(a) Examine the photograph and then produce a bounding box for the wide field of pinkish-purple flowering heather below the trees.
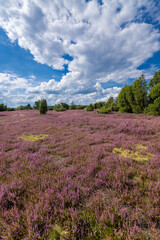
[0,110,160,240]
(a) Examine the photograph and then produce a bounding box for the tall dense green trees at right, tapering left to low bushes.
[87,70,160,115]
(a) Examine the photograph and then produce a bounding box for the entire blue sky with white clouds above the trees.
[0,0,160,107]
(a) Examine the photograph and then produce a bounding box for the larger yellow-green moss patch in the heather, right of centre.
[113,148,151,162]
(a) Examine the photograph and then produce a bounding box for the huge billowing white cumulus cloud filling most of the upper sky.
[0,0,160,105]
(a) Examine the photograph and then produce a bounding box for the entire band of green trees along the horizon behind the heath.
[0,70,160,115]
